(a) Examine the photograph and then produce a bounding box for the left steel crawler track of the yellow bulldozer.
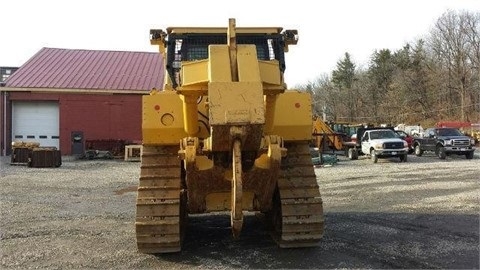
[135,145,186,253]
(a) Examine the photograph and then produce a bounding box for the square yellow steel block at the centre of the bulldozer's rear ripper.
[208,82,265,125]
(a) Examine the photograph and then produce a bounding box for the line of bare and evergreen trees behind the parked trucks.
[300,10,480,126]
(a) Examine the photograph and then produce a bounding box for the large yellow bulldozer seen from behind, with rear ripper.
[135,19,324,253]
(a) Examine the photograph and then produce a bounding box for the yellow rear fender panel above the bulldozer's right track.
[271,91,312,141]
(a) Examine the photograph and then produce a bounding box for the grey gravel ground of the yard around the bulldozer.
[0,153,480,269]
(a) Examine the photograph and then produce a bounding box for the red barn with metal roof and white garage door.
[0,48,164,155]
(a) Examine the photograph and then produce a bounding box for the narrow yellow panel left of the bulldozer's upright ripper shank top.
[208,45,232,82]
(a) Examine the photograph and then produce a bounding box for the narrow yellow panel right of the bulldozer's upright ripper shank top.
[237,45,260,82]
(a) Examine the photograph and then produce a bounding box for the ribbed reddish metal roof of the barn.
[5,48,164,90]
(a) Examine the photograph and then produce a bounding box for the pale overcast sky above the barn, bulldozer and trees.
[0,0,480,87]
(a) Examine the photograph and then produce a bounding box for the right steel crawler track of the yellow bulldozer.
[267,143,324,248]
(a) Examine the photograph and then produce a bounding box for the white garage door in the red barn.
[12,101,60,149]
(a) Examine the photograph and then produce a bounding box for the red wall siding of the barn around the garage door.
[10,92,142,155]
